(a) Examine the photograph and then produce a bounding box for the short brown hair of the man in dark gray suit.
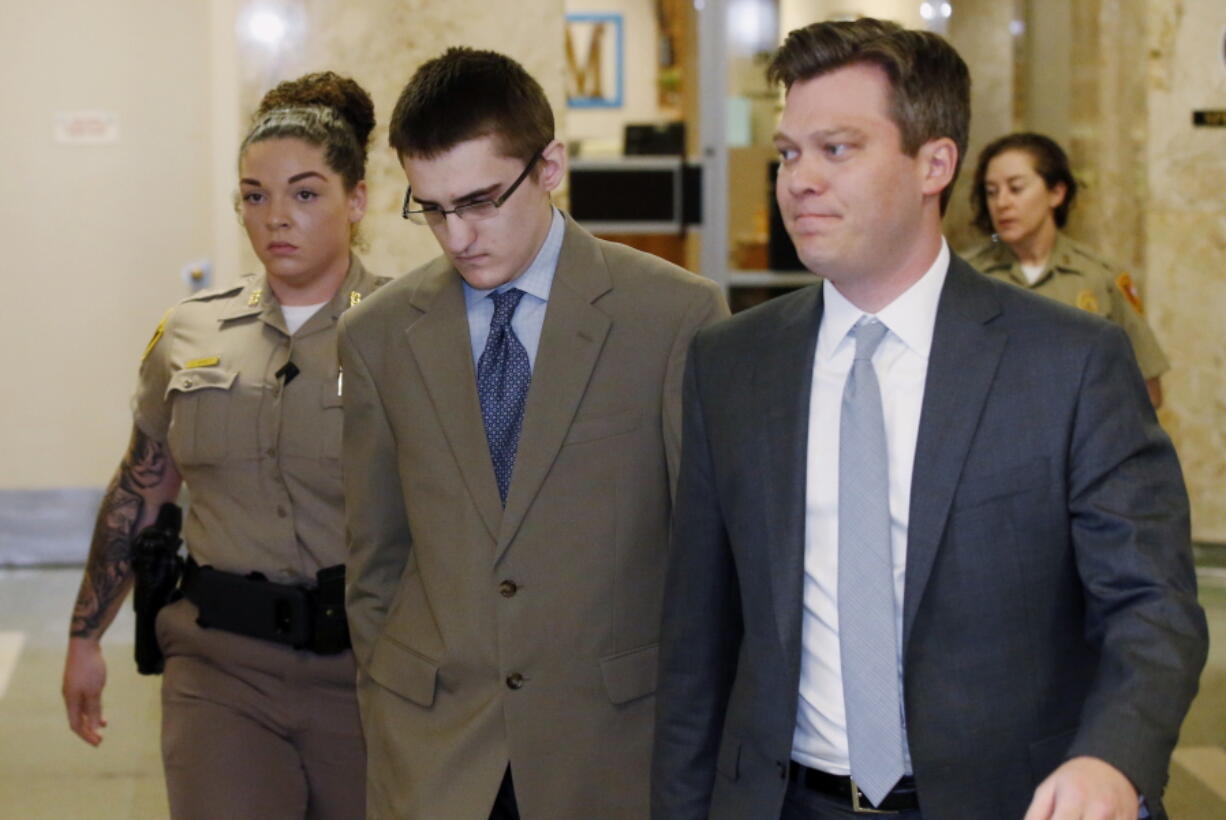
[766,17,971,213]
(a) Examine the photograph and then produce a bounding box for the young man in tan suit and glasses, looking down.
[341,49,727,820]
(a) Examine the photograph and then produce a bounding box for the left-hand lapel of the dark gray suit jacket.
[747,286,823,663]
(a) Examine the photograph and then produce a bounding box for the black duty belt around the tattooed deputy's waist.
[183,558,349,655]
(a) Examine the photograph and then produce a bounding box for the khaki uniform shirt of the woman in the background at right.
[966,234,1171,380]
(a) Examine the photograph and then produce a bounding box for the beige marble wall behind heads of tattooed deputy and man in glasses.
[230,0,565,281]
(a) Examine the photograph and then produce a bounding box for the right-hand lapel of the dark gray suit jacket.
[902,256,1008,646]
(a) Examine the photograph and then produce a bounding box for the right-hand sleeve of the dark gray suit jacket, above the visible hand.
[1068,318,1208,802]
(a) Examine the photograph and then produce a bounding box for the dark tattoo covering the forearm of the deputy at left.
[69,428,170,637]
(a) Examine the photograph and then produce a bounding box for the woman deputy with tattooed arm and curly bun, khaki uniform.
[57,72,381,818]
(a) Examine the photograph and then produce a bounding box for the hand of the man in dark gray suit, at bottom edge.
[1025,757,1139,820]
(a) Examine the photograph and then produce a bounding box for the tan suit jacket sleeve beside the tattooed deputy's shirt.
[340,314,412,668]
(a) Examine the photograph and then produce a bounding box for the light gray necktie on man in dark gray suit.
[839,319,905,805]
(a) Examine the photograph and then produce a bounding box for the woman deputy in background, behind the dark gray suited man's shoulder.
[967,132,1170,407]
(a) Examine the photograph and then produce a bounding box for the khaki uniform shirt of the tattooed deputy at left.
[132,256,386,583]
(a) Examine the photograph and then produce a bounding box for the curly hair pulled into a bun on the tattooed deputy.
[238,71,375,190]
